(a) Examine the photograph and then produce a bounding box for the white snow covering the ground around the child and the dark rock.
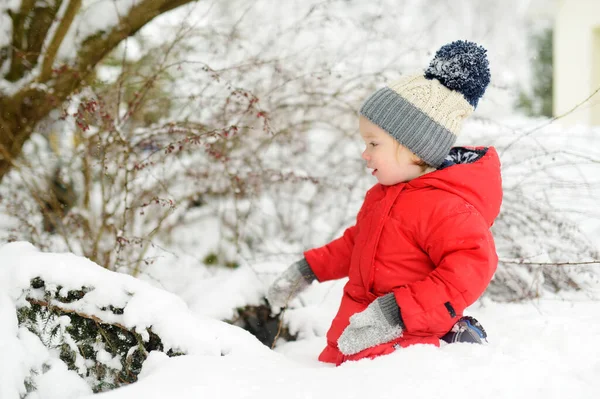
[0,243,600,399]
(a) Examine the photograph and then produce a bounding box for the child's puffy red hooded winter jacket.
[304,147,502,365]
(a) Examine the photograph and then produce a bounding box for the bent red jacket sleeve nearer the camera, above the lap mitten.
[394,211,498,336]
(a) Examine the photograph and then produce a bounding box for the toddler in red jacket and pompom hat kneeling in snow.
[267,40,502,365]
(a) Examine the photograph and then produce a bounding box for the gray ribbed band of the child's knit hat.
[360,87,456,168]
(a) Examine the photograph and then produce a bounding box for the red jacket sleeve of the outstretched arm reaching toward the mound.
[304,226,356,282]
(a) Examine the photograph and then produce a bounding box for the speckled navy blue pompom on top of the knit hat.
[425,40,490,107]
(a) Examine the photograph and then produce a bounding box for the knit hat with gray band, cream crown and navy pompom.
[360,40,490,168]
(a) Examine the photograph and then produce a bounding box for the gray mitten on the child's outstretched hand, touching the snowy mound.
[267,258,317,308]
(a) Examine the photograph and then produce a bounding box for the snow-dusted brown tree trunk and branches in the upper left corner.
[0,0,197,180]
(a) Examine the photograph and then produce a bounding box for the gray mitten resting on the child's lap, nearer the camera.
[338,294,403,355]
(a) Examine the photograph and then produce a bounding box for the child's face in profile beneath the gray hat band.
[359,116,426,186]
